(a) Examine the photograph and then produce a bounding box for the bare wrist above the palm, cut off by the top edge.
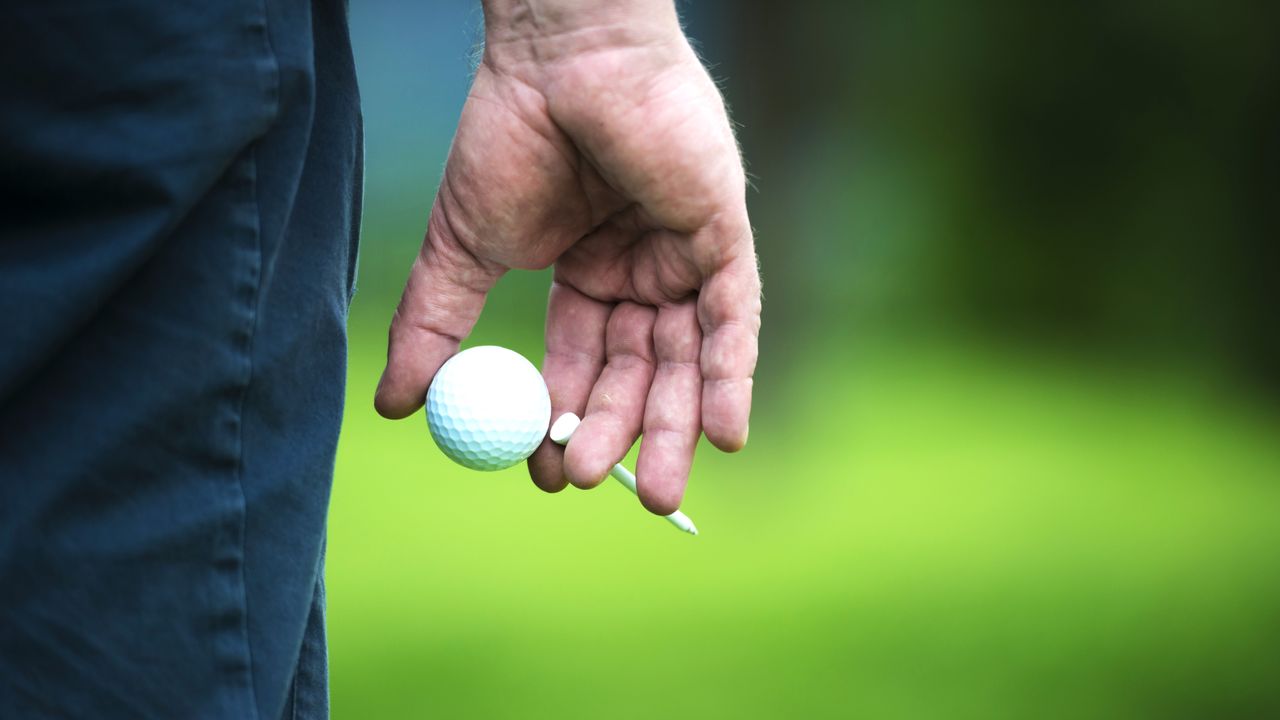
[483,0,687,69]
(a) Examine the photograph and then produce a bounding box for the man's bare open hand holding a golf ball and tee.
[375,0,760,514]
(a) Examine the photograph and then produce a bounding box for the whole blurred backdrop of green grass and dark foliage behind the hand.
[328,0,1280,719]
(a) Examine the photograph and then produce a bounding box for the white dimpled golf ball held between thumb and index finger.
[426,345,552,470]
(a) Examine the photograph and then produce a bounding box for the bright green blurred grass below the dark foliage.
[328,304,1280,719]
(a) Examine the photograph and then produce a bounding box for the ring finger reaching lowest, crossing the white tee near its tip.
[636,300,703,515]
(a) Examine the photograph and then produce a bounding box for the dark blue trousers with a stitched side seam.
[0,0,362,719]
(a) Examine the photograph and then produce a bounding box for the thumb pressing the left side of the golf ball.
[374,200,504,419]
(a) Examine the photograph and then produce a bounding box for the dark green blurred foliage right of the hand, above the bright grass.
[727,0,1280,380]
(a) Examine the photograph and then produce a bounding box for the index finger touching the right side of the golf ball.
[529,282,613,492]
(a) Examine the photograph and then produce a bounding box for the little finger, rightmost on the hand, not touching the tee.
[698,229,760,452]
